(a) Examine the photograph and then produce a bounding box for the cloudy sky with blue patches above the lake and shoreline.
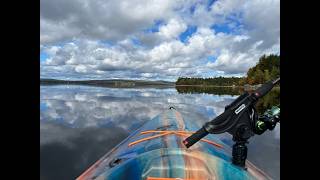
[40,0,280,81]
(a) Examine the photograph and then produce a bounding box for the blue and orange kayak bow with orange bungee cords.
[77,107,271,180]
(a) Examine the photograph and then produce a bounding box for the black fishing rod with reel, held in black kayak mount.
[183,77,280,167]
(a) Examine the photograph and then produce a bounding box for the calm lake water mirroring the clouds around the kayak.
[40,85,280,180]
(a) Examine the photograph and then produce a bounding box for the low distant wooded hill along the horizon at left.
[40,79,175,88]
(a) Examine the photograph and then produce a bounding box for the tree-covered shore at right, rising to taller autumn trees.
[176,54,280,86]
